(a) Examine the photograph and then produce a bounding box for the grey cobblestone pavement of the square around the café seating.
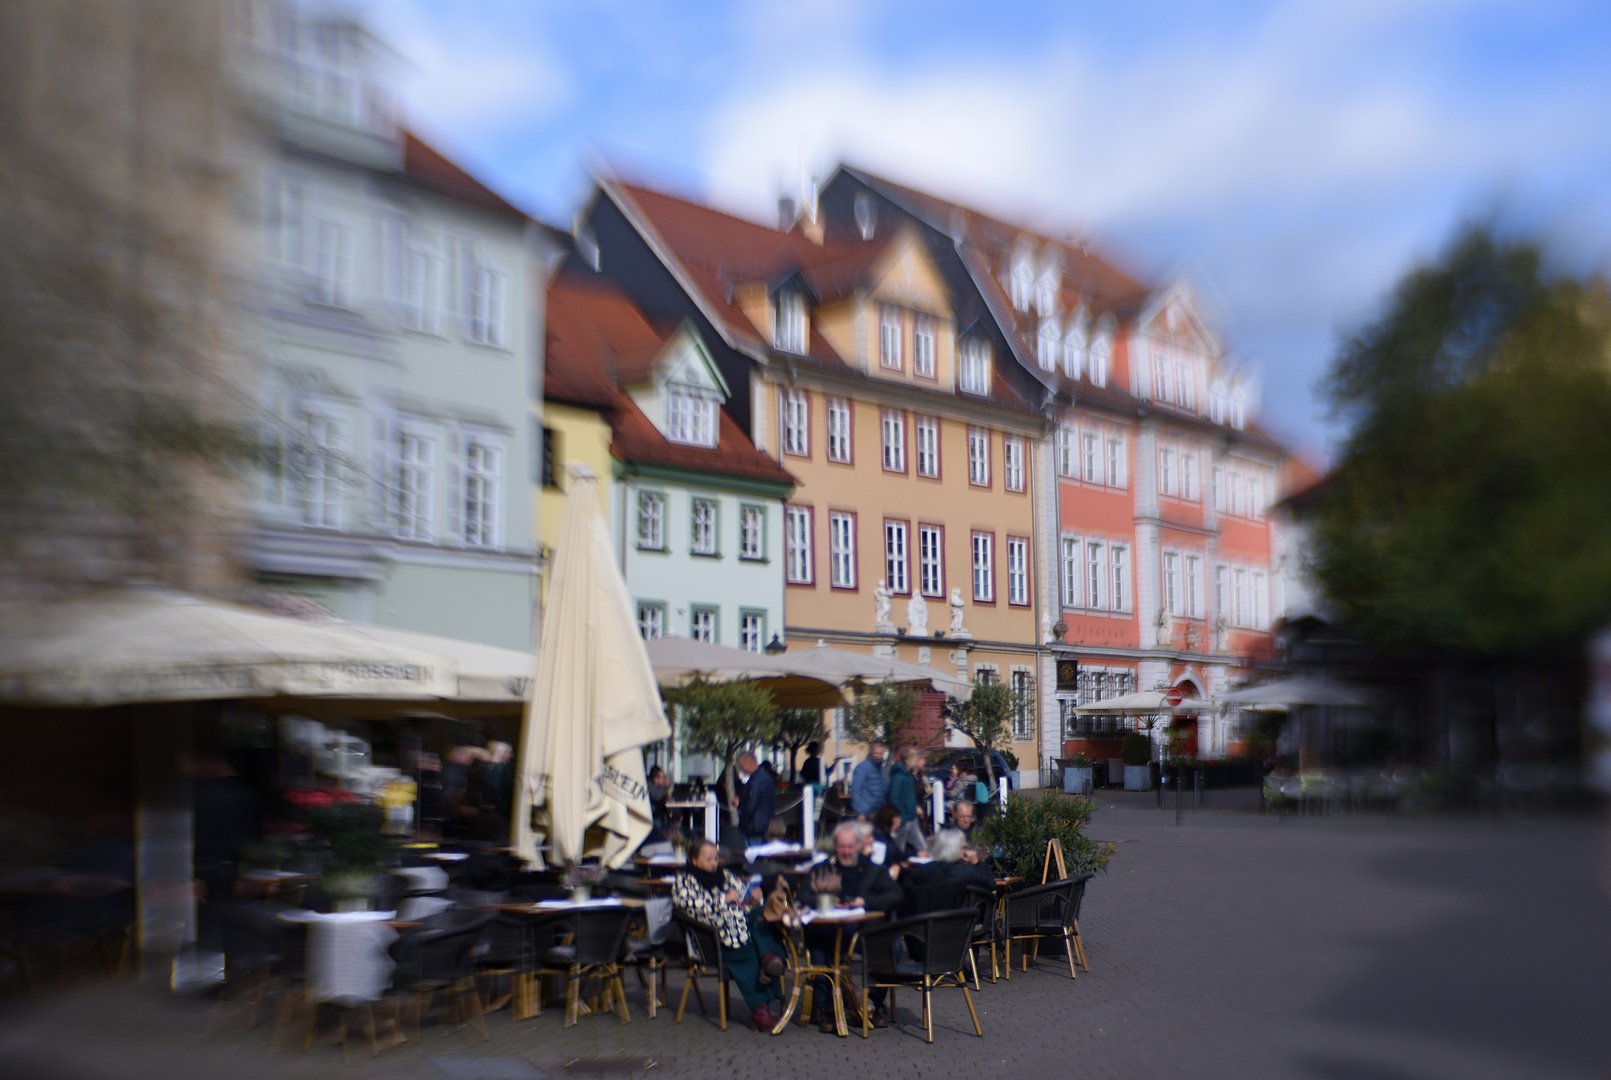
[0,791,1611,1080]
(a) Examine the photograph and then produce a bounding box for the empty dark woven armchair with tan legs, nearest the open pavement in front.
[862,908,984,1043]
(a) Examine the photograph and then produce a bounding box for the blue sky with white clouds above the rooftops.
[356,0,1611,464]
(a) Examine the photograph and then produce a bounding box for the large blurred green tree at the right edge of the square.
[1307,227,1611,653]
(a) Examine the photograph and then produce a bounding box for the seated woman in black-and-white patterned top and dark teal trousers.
[672,840,783,1032]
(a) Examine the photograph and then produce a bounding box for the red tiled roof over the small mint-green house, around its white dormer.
[543,256,796,487]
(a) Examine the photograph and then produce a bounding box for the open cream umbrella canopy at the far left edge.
[0,585,458,708]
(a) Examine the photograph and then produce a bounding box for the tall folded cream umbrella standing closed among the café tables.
[514,469,670,866]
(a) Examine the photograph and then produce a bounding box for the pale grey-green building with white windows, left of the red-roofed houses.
[246,11,551,648]
